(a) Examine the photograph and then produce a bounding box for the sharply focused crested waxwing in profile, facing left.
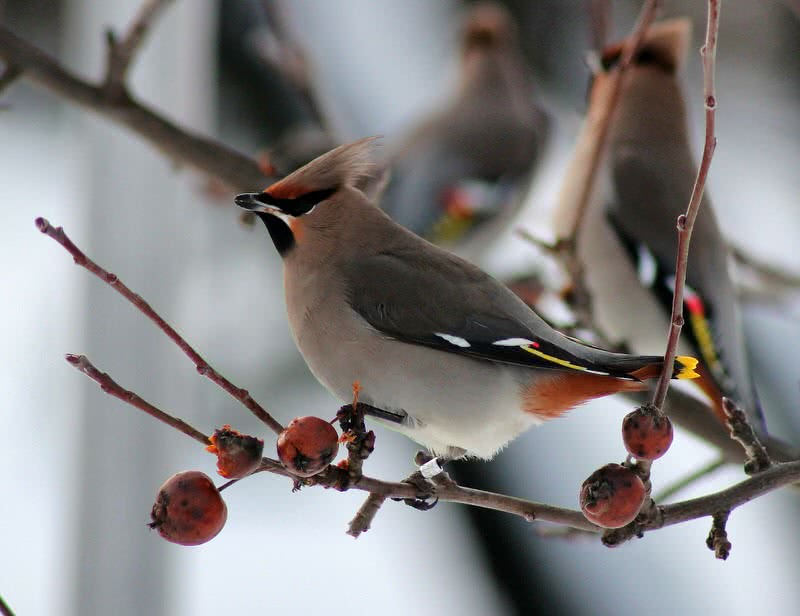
[236,138,696,458]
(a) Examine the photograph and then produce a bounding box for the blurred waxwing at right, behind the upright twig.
[554,19,765,434]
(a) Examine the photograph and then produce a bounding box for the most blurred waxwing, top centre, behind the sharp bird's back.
[383,3,548,247]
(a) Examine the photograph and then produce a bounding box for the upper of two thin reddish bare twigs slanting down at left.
[36,218,283,434]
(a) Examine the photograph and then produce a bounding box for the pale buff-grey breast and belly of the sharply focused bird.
[293,298,540,458]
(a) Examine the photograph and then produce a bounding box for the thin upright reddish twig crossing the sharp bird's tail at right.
[653,0,720,409]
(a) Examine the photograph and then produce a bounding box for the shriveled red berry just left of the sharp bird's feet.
[278,416,339,477]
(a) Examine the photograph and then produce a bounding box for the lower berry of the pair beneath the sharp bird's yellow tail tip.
[580,464,645,528]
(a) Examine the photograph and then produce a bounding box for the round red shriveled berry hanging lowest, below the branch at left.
[150,471,228,545]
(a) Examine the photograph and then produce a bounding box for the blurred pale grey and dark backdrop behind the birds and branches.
[0,0,800,616]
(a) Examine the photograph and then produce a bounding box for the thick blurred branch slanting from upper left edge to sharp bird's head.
[0,26,271,190]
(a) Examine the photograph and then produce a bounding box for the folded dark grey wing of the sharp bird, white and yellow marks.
[346,247,661,378]
